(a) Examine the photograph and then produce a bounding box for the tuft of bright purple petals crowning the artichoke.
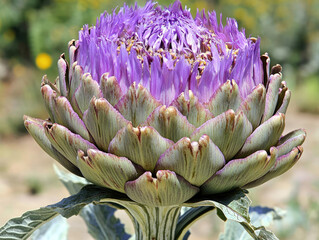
[77,1,263,104]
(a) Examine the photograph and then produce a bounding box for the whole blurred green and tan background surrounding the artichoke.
[0,0,319,240]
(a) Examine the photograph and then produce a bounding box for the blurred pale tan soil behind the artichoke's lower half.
[0,100,319,240]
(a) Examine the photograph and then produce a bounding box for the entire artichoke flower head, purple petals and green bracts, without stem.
[25,1,305,206]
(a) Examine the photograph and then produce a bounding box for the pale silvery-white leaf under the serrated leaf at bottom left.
[30,216,68,240]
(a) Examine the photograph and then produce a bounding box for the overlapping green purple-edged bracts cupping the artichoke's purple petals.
[25,0,305,206]
